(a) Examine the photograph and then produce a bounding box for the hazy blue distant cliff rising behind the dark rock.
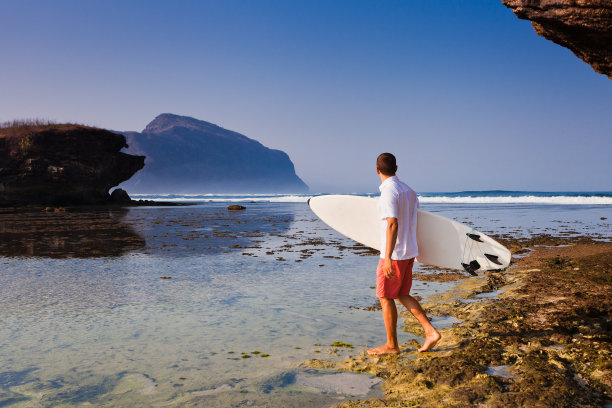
[122,113,308,194]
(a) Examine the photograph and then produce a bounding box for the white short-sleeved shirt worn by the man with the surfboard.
[378,176,419,261]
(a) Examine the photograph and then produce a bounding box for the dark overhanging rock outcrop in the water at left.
[0,125,144,206]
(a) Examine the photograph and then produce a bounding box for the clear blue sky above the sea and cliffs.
[0,0,612,192]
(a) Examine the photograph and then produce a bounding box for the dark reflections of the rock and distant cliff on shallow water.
[0,205,294,258]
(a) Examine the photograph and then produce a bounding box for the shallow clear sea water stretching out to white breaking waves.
[0,191,612,407]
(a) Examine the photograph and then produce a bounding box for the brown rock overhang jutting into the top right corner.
[502,0,612,78]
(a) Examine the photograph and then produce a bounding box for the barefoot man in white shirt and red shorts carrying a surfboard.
[368,153,441,355]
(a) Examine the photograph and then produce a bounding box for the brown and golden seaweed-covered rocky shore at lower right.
[304,236,612,407]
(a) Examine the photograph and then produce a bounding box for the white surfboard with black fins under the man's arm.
[308,195,511,275]
